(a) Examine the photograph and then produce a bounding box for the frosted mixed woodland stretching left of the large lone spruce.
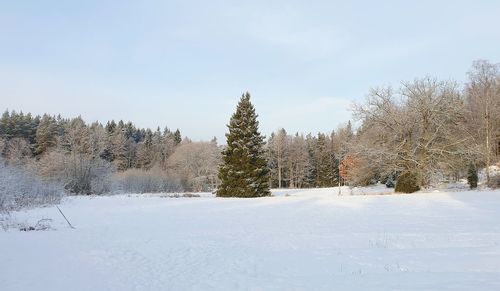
[0,111,220,194]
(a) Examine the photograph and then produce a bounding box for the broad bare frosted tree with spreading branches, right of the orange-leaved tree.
[352,78,473,186]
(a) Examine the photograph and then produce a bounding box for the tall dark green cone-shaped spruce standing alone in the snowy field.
[217,92,271,197]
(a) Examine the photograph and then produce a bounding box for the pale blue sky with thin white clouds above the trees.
[0,0,500,140]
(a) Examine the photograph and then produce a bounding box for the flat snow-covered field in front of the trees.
[0,188,500,291]
